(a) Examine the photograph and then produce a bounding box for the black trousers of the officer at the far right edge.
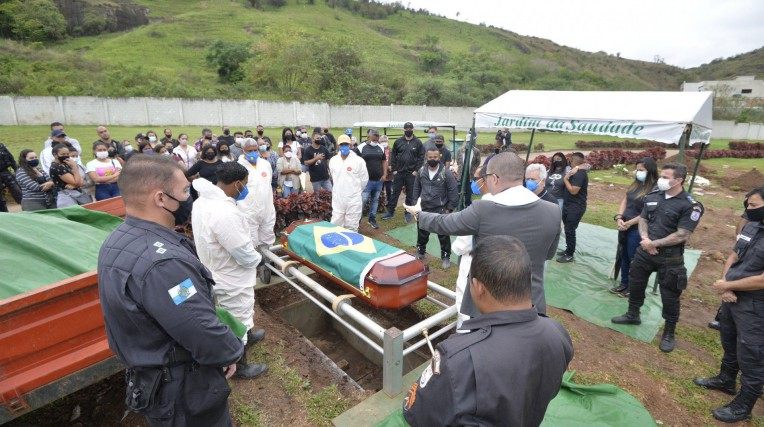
[719,298,764,401]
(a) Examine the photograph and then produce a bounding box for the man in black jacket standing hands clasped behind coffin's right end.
[414,146,459,268]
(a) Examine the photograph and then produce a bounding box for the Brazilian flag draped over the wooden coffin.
[288,221,403,290]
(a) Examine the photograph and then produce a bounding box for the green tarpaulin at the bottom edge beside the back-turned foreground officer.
[377,372,656,427]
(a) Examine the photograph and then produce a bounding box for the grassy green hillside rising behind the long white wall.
[0,0,762,106]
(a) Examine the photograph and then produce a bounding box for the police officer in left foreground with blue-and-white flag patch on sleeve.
[98,154,244,426]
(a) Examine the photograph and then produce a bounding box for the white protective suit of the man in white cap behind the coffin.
[329,151,369,231]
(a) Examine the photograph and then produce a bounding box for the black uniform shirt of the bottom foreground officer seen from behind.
[403,308,573,426]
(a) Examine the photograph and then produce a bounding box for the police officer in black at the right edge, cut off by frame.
[695,187,764,423]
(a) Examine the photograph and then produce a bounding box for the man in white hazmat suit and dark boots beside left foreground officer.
[191,162,268,378]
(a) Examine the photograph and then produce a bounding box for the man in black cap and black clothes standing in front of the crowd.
[382,122,424,222]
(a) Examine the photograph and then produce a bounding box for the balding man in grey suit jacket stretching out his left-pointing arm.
[405,151,561,317]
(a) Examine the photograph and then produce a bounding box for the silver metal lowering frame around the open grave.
[261,245,457,397]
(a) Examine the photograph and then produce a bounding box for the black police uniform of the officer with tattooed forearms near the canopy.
[624,190,703,333]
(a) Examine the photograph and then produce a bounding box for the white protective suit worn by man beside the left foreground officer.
[191,178,262,344]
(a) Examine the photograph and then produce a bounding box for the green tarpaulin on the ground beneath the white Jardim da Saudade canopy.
[544,223,700,342]
